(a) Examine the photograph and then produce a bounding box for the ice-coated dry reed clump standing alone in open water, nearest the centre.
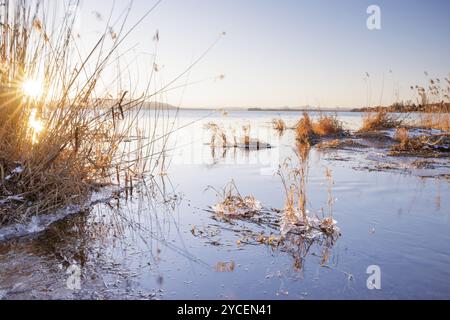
[200,136,340,272]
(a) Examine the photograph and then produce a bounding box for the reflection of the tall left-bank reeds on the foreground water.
[0,177,201,299]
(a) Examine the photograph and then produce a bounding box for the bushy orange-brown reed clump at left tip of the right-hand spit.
[295,112,345,144]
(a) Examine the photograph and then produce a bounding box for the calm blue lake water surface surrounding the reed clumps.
[0,111,450,299]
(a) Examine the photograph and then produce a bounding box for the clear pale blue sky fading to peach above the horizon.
[74,0,450,108]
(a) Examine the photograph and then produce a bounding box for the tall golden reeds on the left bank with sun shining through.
[0,0,165,226]
